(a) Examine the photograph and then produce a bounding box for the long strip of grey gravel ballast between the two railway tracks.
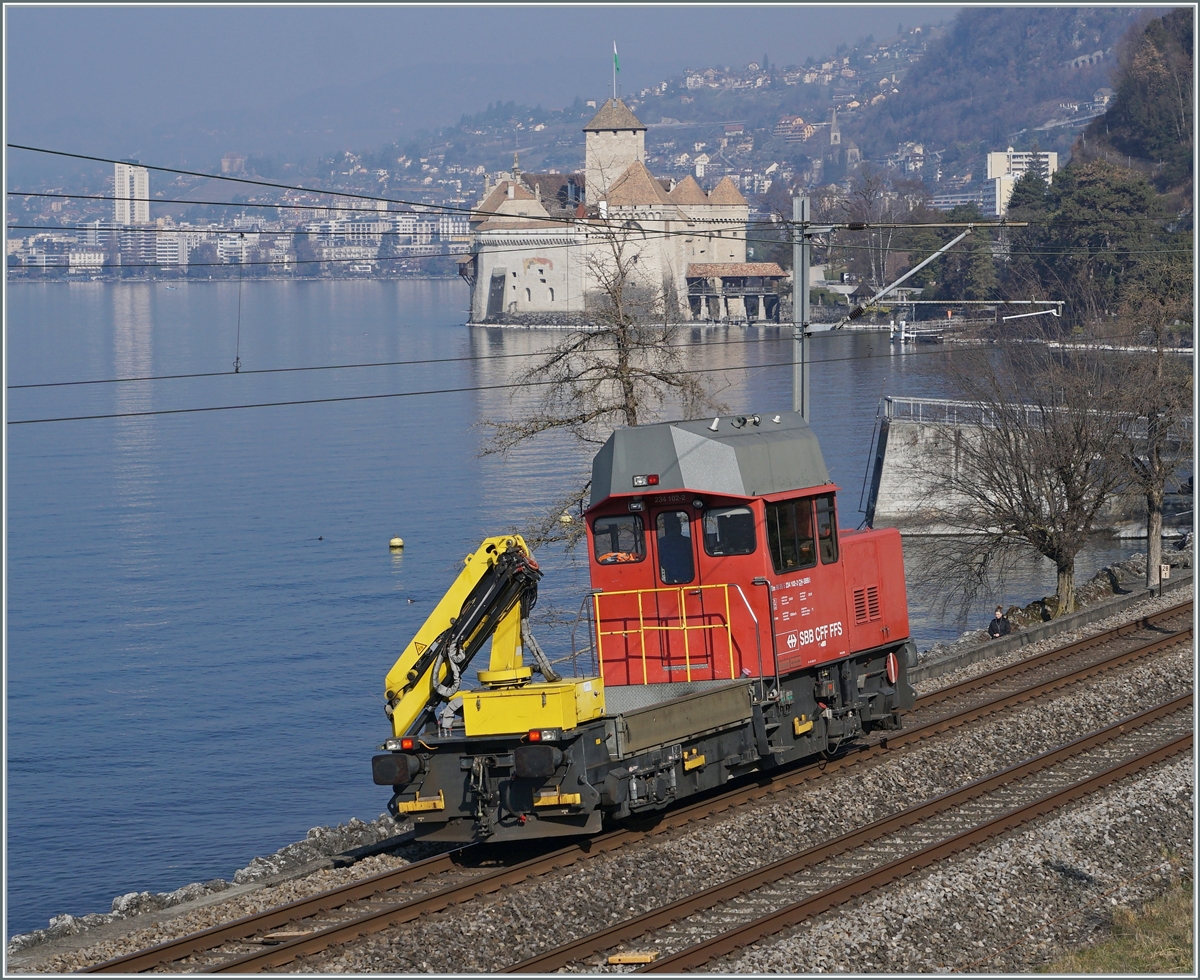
[278,633,1192,973]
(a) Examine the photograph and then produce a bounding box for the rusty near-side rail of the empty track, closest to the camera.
[637,732,1193,973]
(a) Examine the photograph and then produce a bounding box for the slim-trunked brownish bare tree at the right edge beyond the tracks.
[1122,260,1193,589]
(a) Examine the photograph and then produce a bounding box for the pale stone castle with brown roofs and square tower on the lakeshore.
[460,98,787,326]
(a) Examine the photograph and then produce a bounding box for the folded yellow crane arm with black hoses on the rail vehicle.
[386,535,541,736]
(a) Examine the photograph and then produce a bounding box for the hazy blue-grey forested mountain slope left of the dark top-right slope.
[844,6,1144,167]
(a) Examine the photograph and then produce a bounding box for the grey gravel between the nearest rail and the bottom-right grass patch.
[709,753,1194,973]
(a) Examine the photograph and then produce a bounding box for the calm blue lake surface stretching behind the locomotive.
[6,281,1136,936]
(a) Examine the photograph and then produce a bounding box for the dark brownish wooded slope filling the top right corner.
[1078,7,1195,192]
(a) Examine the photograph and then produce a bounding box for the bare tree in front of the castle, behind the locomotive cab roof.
[482,223,725,541]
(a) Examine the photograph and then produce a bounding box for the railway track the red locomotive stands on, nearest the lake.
[80,602,1192,973]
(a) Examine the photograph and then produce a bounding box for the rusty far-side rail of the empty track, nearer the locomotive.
[499,692,1193,973]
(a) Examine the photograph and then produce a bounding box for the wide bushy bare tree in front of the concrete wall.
[920,344,1128,615]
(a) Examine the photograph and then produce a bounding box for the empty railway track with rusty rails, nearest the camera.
[503,693,1193,973]
